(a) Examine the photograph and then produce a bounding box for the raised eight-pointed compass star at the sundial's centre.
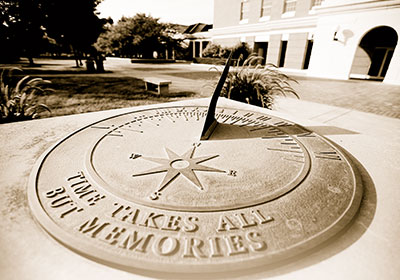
[132,146,225,200]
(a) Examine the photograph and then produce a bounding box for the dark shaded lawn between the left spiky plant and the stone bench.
[8,74,195,118]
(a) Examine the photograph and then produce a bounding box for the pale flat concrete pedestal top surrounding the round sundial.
[0,99,400,279]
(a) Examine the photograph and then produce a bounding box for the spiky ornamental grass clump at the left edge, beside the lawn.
[0,68,51,123]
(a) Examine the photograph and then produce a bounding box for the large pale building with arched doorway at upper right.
[207,0,400,84]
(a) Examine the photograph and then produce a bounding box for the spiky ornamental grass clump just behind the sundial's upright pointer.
[217,55,299,109]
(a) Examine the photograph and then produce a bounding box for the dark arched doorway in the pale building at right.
[350,26,398,80]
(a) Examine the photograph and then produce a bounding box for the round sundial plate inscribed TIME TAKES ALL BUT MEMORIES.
[29,56,362,273]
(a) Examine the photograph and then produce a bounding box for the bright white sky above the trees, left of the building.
[97,0,214,25]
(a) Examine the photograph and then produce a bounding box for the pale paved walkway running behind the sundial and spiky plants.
[5,58,400,118]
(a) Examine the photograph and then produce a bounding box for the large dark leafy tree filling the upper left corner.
[0,0,107,66]
